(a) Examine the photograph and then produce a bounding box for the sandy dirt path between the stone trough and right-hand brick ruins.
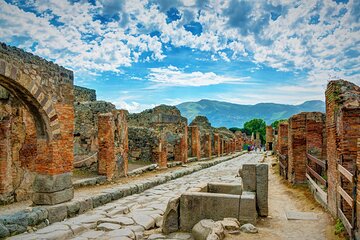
[225,157,345,240]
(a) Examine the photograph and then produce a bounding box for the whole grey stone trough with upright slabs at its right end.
[162,164,268,234]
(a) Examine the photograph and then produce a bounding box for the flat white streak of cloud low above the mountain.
[147,66,249,87]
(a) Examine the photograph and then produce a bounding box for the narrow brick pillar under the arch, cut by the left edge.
[0,119,12,202]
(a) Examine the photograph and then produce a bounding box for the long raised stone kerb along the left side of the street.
[0,152,244,238]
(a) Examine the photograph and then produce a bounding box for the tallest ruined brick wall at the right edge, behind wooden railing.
[325,80,360,221]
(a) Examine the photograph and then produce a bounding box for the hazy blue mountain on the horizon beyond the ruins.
[176,99,325,128]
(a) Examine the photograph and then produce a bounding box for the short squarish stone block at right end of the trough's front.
[239,192,257,224]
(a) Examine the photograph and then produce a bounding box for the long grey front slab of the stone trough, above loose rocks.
[180,192,240,231]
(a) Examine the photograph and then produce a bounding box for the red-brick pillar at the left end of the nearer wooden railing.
[288,113,306,184]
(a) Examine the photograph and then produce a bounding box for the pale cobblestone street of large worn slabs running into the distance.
[11,154,263,240]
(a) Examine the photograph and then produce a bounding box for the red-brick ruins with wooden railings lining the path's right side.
[269,80,360,239]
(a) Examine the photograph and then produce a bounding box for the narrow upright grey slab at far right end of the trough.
[256,163,269,216]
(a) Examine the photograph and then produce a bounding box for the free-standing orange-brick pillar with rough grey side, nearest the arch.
[98,110,128,180]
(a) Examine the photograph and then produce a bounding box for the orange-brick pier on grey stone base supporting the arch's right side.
[32,103,74,205]
